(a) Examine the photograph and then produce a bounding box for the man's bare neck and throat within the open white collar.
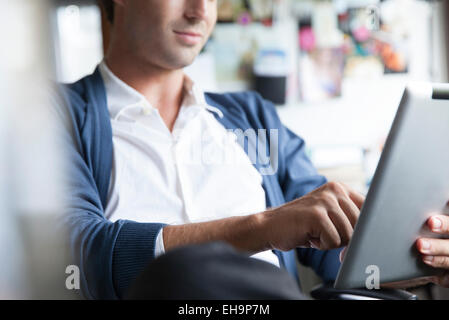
[105,53,184,131]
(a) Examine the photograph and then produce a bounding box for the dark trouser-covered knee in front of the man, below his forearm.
[125,242,304,300]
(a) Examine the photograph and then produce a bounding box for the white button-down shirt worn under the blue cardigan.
[100,62,279,266]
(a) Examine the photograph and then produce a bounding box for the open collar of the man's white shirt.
[99,60,223,119]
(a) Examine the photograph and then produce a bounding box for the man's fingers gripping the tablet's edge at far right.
[416,202,449,288]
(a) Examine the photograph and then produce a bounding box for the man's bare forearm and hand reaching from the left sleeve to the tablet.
[163,182,365,253]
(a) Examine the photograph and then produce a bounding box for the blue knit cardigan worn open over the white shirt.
[53,69,340,299]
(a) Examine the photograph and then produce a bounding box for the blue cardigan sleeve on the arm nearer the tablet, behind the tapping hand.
[254,94,341,282]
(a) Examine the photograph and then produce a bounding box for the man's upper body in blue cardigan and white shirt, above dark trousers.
[55,0,448,299]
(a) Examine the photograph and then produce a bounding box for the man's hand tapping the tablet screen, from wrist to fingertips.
[263,182,365,251]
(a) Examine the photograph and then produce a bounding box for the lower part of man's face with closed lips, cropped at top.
[116,0,217,70]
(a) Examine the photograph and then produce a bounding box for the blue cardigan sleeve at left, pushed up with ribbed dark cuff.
[52,88,164,299]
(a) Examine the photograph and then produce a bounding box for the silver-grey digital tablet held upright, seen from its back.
[334,83,449,289]
